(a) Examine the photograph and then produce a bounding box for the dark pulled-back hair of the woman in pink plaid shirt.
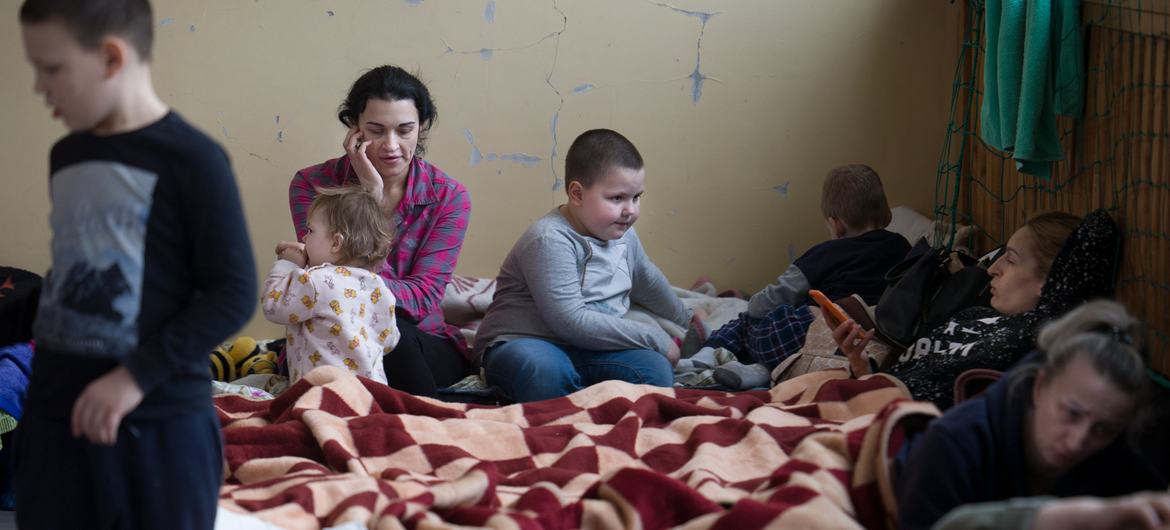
[337,64,439,157]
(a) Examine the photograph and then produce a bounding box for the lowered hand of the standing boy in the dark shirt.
[71,366,143,446]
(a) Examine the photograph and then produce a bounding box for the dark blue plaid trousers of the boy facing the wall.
[703,305,813,370]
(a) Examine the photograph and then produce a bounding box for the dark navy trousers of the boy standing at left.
[13,407,223,530]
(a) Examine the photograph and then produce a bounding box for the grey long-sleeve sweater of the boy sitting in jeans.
[474,208,688,364]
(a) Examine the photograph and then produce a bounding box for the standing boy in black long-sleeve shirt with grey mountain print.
[15,0,256,529]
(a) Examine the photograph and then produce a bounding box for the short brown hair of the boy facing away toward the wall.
[820,164,892,230]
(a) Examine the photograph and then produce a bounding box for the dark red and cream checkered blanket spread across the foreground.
[215,367,937,529]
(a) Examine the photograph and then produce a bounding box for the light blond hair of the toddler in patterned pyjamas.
[309,186,394,273]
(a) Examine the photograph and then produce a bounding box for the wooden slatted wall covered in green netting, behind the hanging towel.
[934,0,1170,381]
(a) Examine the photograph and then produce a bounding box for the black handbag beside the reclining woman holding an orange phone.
[874,238,998,349]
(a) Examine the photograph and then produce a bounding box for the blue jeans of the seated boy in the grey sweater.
[483,338,674,402]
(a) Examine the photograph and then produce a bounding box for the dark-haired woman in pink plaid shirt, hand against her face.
[289,66,472,395]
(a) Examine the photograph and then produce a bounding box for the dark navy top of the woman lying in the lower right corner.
[897,358,1166,529]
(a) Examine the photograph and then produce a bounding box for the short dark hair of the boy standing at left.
[20,0,154,61]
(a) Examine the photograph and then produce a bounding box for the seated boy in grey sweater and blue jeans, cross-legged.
[474,129,689,402]
